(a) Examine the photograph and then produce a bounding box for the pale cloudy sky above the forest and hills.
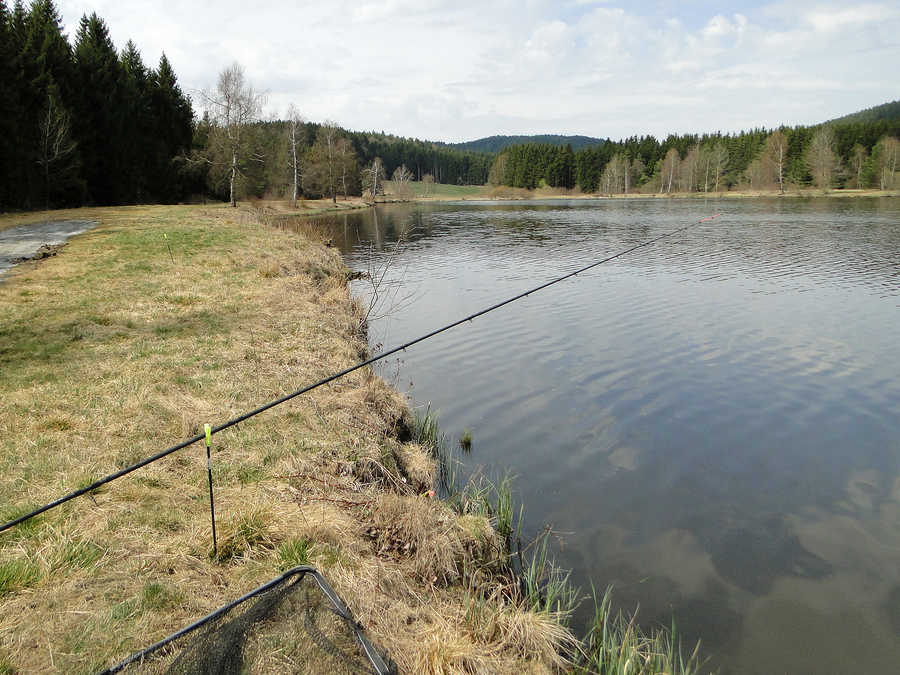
[57,0,900,142]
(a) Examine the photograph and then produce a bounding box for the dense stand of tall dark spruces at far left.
[0,0,196,209]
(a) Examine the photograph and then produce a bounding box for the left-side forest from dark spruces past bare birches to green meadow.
[0,0,493,209]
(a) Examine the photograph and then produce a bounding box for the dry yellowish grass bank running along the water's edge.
[0,206,569,673]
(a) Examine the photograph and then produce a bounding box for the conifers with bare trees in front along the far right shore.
[490,118,900,194]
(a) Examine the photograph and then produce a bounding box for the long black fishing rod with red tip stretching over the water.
[0,213,722,532]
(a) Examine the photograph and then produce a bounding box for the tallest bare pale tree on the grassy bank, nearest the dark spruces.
[203,62,266,206]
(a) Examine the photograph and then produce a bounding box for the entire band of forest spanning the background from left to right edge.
[0,0,900,209]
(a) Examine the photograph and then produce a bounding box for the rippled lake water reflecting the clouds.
[326,199,900,673]
